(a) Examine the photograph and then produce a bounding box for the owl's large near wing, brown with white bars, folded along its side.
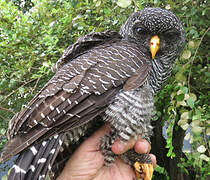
[1,41,149,161]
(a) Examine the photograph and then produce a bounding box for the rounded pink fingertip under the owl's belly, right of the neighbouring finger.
[134,139,151,154]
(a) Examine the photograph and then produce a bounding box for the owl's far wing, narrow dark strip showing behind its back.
[52,30,121,72]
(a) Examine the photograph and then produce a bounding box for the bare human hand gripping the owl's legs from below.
[57,125,156,180]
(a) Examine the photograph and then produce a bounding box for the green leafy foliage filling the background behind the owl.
[0,0,210,179]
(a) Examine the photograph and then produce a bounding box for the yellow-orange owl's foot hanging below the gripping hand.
[133,162,154,180]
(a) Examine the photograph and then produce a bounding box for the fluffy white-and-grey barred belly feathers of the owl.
[104,85,154,140]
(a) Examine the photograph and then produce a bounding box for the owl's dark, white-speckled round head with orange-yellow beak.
[120,8,185,60]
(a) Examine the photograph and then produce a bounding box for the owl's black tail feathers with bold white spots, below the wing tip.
[8,134,64,180]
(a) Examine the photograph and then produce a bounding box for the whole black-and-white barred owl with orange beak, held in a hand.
[1,8,185,180]
